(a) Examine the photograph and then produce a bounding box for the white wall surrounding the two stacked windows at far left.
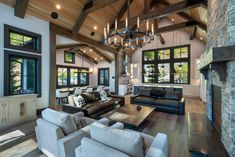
[0,3,49,109]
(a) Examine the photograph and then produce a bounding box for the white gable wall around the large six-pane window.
[132,20,205,97]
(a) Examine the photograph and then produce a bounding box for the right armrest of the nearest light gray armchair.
[145,133,168,157]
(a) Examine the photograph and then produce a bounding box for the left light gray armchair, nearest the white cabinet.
[35,109,109,157]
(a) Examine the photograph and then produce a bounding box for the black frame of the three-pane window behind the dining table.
[56,65,90,89]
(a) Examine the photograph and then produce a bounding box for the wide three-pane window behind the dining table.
[57,65,89,88]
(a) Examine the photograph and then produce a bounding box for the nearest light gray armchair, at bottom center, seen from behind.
[76,122,168,157]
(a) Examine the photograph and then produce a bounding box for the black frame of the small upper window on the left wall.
[4,24,42,54]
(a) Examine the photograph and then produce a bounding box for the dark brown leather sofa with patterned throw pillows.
[62,91,125,118]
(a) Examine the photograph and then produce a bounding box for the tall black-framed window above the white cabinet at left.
[4,51,41,96]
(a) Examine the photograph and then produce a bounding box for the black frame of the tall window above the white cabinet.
[4,50,42,97]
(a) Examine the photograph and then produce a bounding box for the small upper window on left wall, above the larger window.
[4,25,41,53]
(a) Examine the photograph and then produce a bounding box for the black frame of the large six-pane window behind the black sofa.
[142,44,191,85]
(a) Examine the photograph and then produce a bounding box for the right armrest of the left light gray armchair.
[58,130,89,157]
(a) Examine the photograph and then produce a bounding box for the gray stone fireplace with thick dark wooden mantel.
[200,0,235,157]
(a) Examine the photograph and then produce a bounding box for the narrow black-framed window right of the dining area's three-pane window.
[98,68,109,86]
